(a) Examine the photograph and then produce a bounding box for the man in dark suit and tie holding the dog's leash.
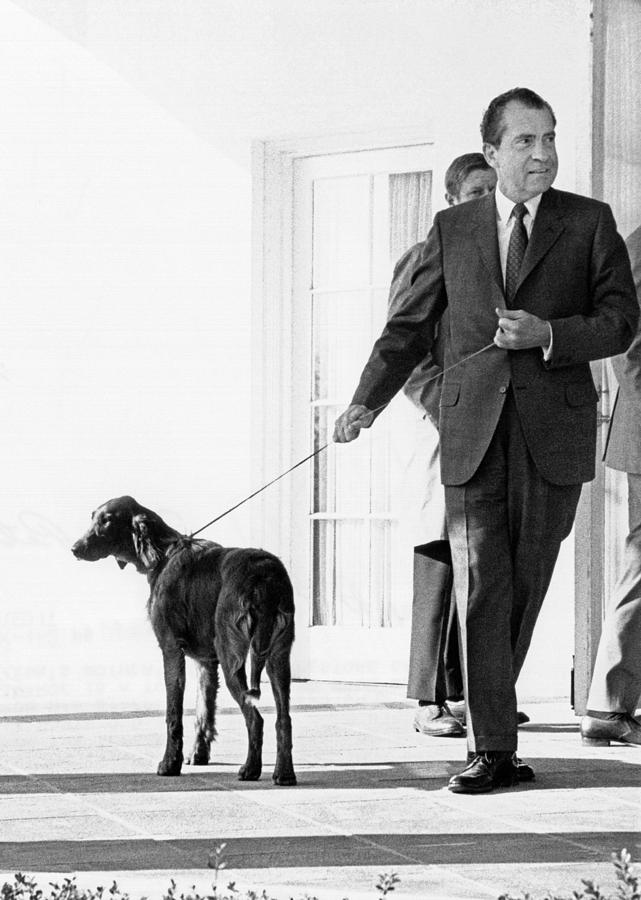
[334,88,638,793]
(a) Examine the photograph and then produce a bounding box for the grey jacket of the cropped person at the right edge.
[605,227,641,475]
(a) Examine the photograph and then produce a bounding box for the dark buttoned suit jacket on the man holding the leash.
[352,188,639,484]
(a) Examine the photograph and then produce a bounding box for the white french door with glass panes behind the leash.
[290,145,432,682]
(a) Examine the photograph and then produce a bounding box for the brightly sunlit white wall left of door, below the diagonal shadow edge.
[0,4,250,712]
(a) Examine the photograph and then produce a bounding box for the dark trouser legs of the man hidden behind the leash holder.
[407,540,463,706]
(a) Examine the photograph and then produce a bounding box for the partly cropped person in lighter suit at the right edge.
[581,228,641,747]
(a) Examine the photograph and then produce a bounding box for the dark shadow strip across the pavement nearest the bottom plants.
[0,831,641,872]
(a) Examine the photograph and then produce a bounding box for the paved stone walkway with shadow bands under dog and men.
[0,682,641,900]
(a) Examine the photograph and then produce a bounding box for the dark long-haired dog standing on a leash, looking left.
[72,497,296,785]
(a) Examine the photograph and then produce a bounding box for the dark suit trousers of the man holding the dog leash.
[445,388,581,752]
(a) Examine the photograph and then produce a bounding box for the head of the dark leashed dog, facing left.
[71,497,172,572]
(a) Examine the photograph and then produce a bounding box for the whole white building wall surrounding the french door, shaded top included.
[0,0,589,714]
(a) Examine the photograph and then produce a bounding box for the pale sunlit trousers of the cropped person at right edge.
[588,473,641,715]
